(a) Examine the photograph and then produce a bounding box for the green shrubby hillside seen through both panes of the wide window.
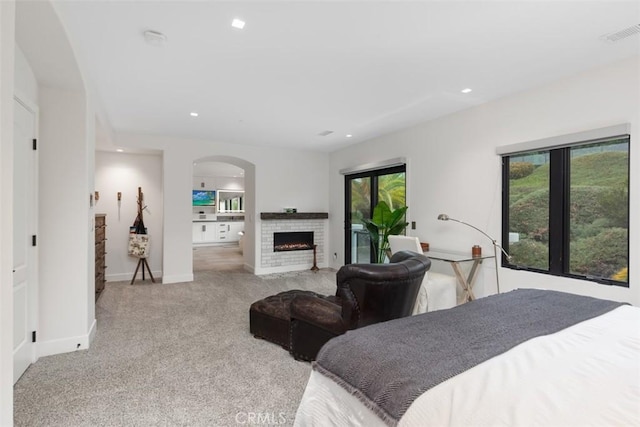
[509,151,629,277]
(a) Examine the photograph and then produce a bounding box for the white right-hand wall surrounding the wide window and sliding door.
[330,57,640,305]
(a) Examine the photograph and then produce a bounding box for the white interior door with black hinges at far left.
[13,99,37,384]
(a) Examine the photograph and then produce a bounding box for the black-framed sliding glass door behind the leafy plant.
[344,165,406,264]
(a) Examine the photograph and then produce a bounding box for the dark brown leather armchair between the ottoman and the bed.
[289,251,431,361]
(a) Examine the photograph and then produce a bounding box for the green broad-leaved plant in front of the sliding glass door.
[362,201,409,264]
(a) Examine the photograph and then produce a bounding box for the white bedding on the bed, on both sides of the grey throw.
[295,306,640,427]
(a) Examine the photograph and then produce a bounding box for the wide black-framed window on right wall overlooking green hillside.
[502,135,630,286]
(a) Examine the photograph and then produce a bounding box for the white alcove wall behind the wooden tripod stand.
[95,151,163,282]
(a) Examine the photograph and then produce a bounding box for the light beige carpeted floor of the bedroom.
[14,270,335,426]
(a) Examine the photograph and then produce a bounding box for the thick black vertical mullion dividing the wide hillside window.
[549,149,569,274]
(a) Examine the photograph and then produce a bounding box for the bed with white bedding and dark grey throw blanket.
[295,289,640,427]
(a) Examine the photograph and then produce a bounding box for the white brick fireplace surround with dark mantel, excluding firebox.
[260,212,329,272]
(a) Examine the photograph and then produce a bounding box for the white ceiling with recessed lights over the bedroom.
[50,0,640,151]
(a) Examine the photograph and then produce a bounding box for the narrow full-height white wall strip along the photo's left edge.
[0,0,15,426]
